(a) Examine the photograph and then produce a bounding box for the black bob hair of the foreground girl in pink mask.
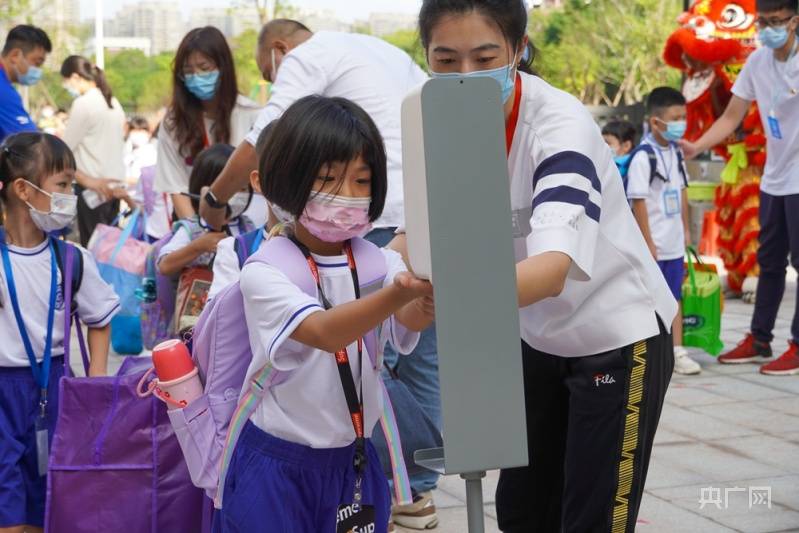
[258,96,388,222]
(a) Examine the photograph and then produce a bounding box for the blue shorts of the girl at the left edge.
[0,357,64,527]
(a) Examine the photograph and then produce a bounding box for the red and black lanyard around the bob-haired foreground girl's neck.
[292,239,366,474]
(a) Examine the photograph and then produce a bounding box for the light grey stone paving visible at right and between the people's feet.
[398,273,799,533]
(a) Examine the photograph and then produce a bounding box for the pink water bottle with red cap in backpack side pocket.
[139,340,203,409]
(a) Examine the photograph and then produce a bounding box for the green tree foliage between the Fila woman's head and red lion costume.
[530,0,682,105]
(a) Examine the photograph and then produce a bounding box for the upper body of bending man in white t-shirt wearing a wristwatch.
[200,19,427,232]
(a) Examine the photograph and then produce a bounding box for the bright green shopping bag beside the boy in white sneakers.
[682,247,724,355]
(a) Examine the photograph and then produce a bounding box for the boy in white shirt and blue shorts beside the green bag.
[627,87,701,374]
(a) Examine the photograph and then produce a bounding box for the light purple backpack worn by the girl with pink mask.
[168,237,410,509]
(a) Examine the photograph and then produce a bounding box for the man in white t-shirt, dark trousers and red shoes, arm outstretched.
[682,0,799,375]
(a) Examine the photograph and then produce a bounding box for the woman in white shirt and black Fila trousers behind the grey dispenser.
[419,0,677,533]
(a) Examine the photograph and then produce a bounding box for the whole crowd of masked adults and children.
[0,0,799,533]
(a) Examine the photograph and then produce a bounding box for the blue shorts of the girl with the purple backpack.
[213,422,391,533]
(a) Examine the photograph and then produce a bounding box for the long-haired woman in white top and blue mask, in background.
[155,26,266,225]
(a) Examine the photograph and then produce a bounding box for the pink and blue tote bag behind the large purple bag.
[88,209,151,355]
